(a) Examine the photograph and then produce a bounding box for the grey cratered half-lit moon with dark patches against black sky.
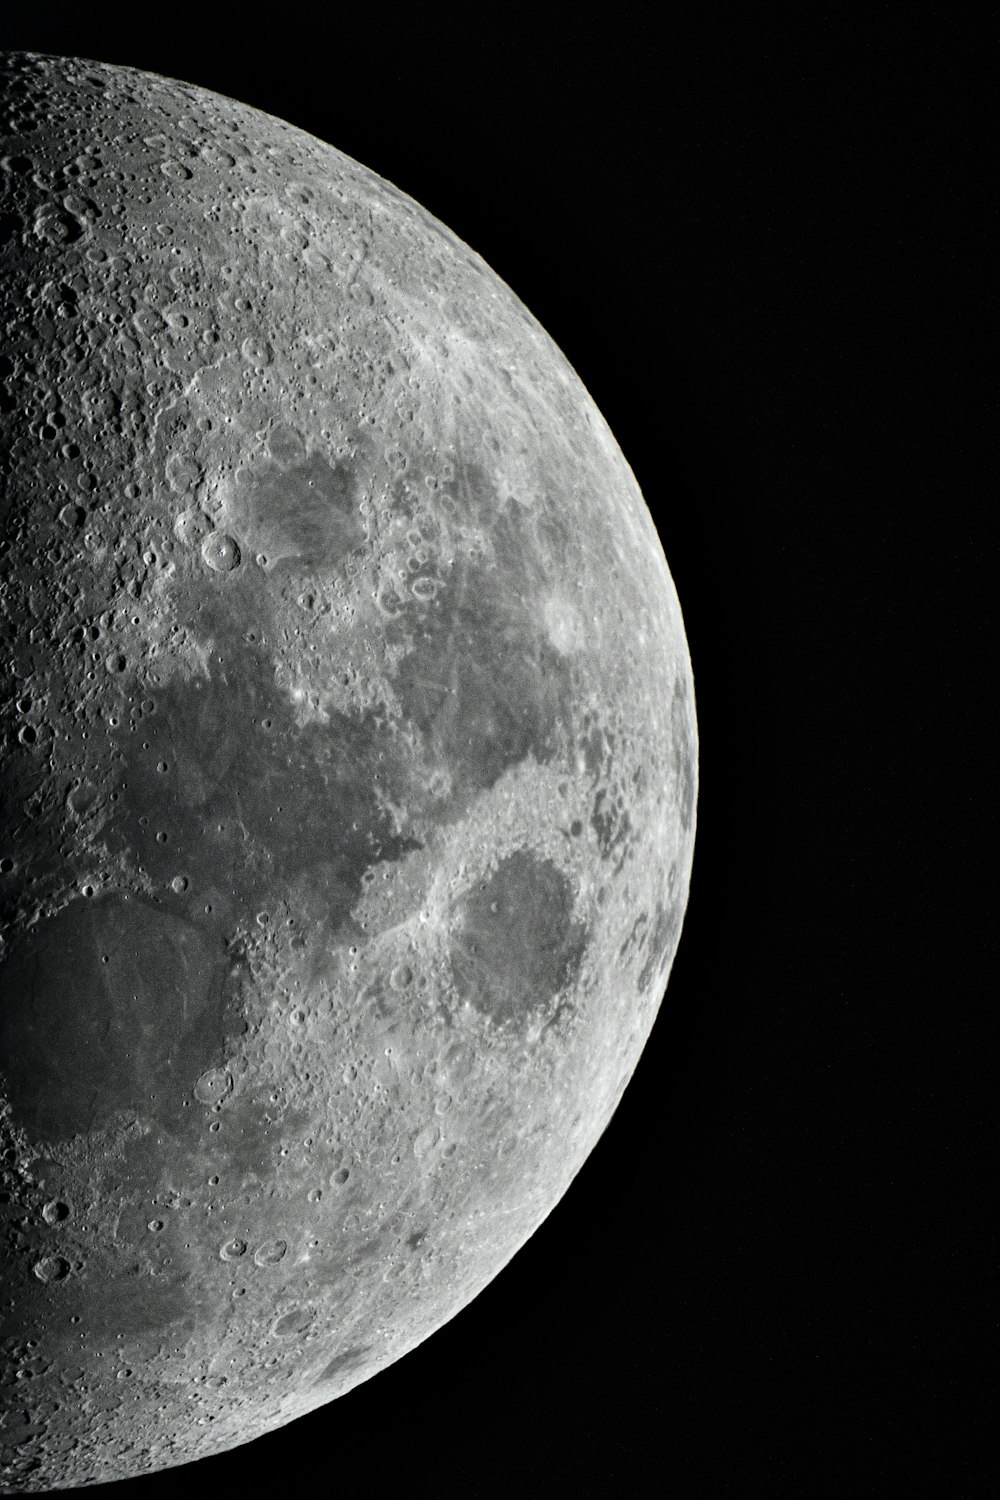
[0,54,697,1491]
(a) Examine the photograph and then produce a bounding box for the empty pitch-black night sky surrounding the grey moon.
[0,3,996,1500]
